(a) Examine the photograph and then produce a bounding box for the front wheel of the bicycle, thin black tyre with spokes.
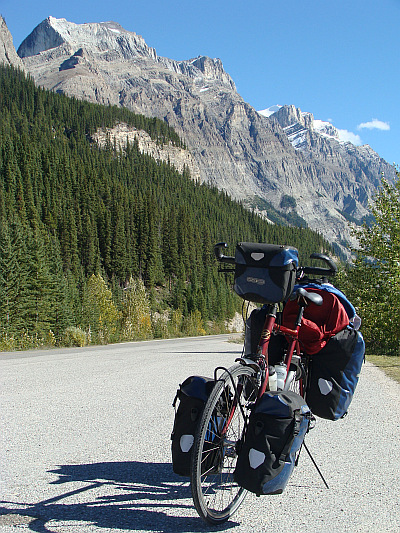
[191,364,258,524]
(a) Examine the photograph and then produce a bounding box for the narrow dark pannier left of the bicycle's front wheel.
[171,376,215,476]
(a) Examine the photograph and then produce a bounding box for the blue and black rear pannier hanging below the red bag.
[306,327,365,420]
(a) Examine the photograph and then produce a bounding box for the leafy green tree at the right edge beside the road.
[342,175,400,355]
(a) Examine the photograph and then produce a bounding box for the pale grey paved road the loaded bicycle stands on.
[0,336,400,533]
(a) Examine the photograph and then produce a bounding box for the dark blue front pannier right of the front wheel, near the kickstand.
[234,391,313,496]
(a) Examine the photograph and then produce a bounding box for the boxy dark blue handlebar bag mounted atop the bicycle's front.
[233,242,298,303]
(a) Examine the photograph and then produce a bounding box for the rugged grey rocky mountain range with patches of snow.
[0,17,395,255]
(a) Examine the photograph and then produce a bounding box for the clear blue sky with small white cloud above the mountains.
[0,0,400,165]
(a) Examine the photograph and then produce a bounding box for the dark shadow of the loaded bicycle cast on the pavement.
[0,461,237,533]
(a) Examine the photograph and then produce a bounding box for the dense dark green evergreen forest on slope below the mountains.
[0,66,330,350]
